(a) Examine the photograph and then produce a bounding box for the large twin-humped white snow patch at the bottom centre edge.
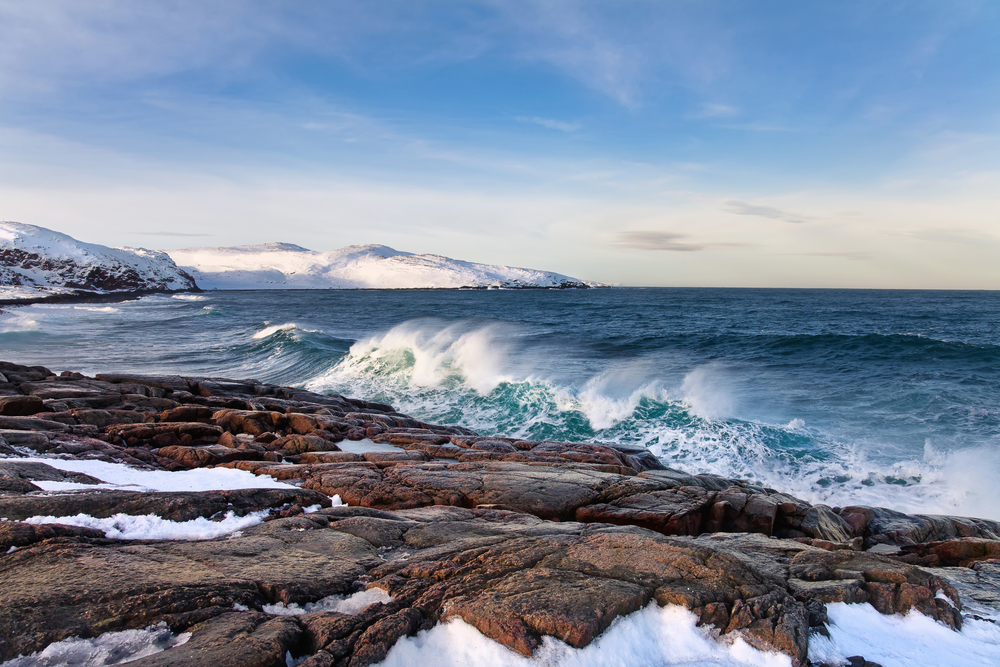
[379,603,792,667]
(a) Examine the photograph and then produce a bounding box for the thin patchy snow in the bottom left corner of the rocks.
[0,623,191,667]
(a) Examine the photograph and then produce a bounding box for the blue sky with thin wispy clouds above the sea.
[0,0,1000,289]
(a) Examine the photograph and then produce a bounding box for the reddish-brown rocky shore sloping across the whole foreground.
[0,362,1000,667]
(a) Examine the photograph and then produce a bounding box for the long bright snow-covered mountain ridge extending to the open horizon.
[167,243,601,289]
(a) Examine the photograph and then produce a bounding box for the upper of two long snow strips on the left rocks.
[4,458,296,491]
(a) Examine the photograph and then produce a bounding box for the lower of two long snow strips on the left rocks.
[23,510,269,540]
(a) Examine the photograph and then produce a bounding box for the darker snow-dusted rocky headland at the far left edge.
[0,222,197,299]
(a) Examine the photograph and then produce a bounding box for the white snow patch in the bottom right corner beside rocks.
[809,602,1000,667]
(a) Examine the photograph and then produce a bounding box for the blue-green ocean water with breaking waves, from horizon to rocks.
[0,288,1000,519]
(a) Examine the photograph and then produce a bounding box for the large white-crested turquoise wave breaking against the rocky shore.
[304,319,1000,518]
